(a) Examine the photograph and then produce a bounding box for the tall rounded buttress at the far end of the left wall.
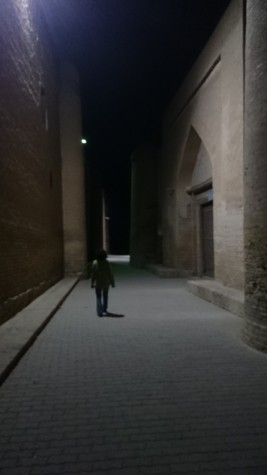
[60,63,87,275]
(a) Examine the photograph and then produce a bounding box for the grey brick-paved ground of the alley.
[0,265,267,475]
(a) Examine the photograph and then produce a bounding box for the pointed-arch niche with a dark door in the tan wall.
[177,126,214,277]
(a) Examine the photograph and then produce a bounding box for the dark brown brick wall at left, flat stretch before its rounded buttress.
[0,0,63,323]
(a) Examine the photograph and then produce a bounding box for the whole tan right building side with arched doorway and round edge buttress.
[131,0,267,351]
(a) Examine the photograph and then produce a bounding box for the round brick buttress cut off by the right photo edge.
[243,0,267,352]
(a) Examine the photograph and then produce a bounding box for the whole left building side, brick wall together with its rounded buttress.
[0,0,86,323]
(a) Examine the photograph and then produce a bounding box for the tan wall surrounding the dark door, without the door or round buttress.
[160,0,244,289]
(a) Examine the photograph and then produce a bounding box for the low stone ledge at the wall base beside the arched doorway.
[187,279,244,317]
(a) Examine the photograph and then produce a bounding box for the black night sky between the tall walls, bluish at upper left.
[45,0,230,253]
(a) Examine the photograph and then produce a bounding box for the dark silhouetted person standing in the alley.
[91,249,115,317]
